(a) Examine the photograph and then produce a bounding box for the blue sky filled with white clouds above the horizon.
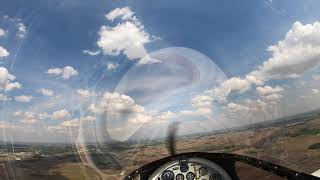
[0,0,320,142]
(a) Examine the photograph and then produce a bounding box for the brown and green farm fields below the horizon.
[0,114,320,180]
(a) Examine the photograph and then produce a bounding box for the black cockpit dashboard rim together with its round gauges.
[125,152,319,180]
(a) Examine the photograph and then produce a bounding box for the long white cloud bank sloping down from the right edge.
[208,22,320,99]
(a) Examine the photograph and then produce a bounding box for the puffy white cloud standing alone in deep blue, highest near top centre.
[97,7,159,64]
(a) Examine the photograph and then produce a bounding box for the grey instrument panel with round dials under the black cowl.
[149,157,231,180]
